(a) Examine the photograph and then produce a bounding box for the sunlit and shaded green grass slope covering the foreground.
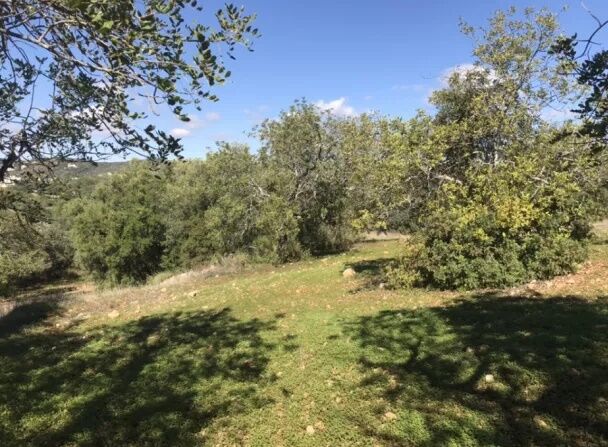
[0,241,608,447]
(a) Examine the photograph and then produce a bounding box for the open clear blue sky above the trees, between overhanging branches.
[156,0,608,157]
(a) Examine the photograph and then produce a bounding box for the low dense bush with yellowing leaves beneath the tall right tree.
[393,160,590,290]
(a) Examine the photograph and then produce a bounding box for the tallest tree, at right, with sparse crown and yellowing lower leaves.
[384,10,597,289]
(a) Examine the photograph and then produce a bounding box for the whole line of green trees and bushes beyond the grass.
[0,11,608,289]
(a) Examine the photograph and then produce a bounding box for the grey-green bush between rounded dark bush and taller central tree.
[164,144,300,266]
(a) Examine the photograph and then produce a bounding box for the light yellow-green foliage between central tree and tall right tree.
[339,111,441,232]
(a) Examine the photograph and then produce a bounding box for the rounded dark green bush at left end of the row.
[68,162,165,284]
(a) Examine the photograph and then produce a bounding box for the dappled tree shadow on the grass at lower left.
[0,308,275,447]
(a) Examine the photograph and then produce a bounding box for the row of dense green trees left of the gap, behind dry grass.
[66,126,352,284]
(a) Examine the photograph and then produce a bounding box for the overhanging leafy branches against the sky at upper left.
[0,0,258,182]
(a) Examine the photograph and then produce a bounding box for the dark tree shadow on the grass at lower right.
[347,295,608,446]
